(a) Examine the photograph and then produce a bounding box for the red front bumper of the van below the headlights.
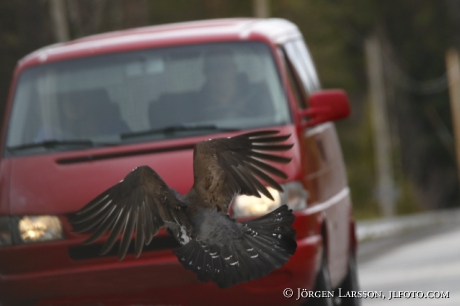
[0,215,322,306]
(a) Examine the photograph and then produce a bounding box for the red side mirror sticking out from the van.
[300,89,350,127]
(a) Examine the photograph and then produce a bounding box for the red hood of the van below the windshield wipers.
[0,127,299,215]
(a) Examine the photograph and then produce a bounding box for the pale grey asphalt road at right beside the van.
[358,224,460,306]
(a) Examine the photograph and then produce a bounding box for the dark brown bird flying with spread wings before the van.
[70,131,297,288]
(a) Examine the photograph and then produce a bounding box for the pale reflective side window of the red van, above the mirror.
[284,39,320,93]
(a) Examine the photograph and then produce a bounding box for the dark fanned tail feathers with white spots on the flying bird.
[174,205,297,288]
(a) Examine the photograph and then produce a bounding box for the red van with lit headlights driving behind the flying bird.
[0,18,359,305]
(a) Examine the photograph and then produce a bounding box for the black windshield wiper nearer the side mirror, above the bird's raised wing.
[120,124,239,139]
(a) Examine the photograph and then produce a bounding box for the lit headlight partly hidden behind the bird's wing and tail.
[233,182,308,218]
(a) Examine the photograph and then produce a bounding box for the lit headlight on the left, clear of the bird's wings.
[18,216,63,243]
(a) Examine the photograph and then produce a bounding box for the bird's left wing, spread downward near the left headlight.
[70,166,190,260]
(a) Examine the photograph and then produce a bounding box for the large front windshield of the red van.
[7,42,290,154]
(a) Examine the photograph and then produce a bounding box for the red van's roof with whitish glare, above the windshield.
[19,18,301,68]
